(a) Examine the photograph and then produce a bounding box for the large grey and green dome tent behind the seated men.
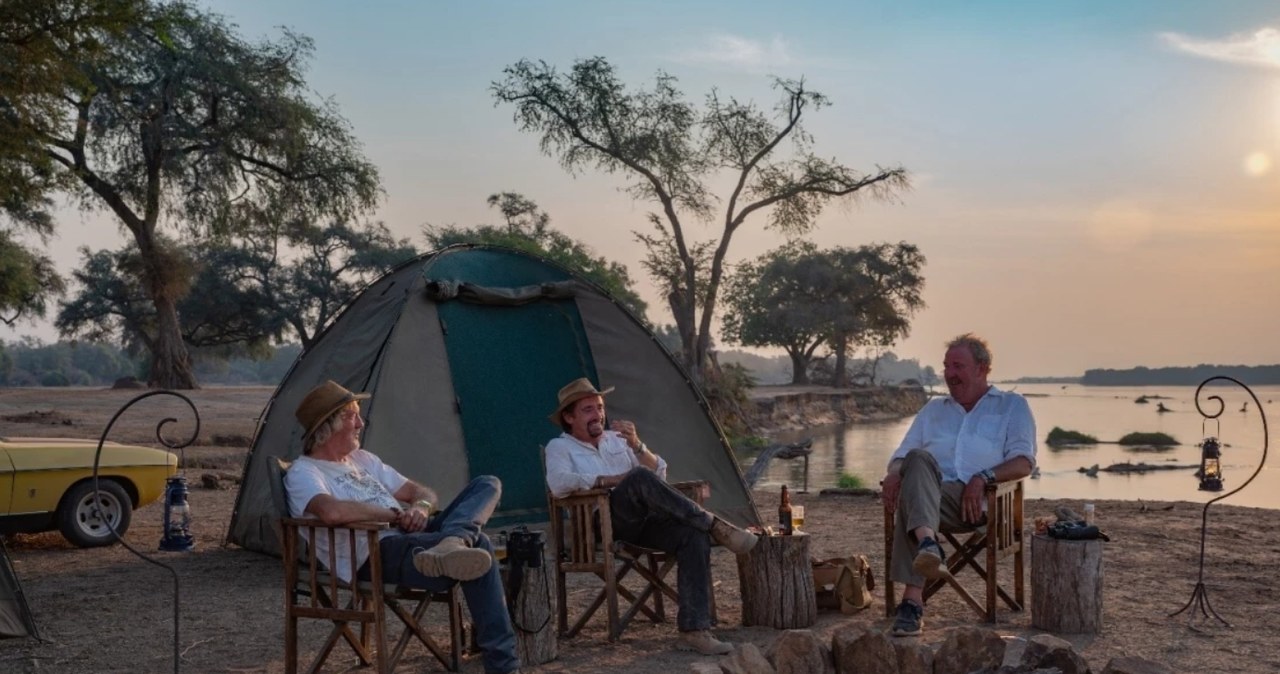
[228,246,759,553]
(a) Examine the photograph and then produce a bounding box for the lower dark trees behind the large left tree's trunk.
[56,223,417,357]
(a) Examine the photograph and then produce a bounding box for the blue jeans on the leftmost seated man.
[379,474,520,673]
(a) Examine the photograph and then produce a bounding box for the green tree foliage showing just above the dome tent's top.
[422,192,649,325]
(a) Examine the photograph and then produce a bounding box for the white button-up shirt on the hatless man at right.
[890,386,1036,482]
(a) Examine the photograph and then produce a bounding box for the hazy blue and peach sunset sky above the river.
[0,0,1280,377]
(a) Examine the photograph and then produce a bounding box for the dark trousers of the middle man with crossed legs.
[609,467,714,632]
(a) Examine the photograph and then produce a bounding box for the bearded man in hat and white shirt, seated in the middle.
[547,377,756,655]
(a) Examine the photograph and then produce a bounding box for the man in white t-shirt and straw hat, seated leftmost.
[284,381,520,674]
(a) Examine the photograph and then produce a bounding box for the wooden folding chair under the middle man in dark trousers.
[547,481,716,641]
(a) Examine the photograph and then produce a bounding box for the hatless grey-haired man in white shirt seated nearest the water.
[881,333,1036,637]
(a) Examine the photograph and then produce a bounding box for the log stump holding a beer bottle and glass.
[737,533,818,629]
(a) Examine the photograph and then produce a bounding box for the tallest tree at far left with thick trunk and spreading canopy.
[0,0,380,389]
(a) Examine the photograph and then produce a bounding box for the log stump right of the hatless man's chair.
[1032,535,1102,634]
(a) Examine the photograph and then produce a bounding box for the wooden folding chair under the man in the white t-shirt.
[270,459,462,674]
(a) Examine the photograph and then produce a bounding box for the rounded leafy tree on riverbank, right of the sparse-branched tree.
[723,242,924,386]
